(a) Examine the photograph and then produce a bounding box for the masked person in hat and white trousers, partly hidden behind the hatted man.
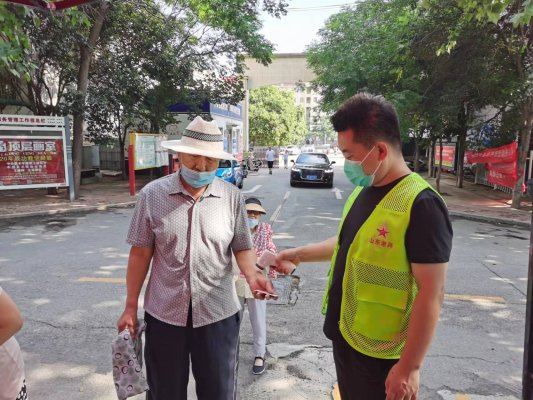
[235,197,277,375]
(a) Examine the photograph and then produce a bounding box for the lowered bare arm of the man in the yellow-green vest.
[385,263,448,400]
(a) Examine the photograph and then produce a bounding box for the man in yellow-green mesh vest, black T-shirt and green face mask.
[276,93,453,400]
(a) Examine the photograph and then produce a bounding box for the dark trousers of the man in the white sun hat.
[144,309,240,400]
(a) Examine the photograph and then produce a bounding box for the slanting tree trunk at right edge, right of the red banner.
[511,97,533,209]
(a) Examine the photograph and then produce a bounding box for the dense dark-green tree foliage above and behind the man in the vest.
[308,0,520,191]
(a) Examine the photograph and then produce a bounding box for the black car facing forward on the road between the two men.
[290,153,335,187]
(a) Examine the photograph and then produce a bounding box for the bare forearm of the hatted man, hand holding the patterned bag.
[117,246,154,336]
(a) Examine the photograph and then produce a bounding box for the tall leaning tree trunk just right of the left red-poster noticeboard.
[72,1,109,197]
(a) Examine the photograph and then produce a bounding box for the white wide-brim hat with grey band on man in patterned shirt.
[161,116,236,160]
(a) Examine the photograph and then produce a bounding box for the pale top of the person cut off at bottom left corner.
[0,287,24,400]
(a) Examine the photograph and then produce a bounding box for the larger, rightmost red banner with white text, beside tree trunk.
[466,142,518,188]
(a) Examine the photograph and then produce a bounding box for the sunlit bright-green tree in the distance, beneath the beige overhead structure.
[249,86,307,146]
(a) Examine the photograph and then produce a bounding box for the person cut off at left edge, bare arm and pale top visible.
[0,287,28,400]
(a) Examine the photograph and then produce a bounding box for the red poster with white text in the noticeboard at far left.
[0,136,68,189]
